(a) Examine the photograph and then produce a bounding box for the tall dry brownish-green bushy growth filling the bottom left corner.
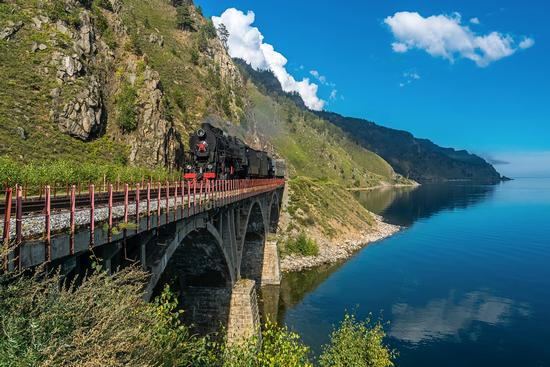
[0,269,215,367]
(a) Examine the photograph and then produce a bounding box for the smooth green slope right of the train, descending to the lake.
[248,83,395,187]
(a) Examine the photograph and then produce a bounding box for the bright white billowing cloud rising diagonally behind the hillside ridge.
[212,8,326,111]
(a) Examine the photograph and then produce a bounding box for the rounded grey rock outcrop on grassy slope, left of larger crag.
[58,76,103,140]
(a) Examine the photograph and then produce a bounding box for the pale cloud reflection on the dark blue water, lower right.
[389,291,530,344]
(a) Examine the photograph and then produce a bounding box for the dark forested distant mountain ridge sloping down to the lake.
[235,59,502,183]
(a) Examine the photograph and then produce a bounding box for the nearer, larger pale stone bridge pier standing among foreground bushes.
[227,279,261,345]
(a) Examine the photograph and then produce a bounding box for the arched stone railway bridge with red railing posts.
[0,179,285,341]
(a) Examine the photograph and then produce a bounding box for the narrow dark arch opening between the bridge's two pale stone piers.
[239,201,267,285]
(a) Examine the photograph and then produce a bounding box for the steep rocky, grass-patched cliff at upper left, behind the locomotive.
[0,0,245,167]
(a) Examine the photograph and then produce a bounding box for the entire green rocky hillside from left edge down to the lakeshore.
[0,0,410,247]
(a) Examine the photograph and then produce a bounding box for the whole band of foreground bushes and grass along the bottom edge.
[0,264,395,367]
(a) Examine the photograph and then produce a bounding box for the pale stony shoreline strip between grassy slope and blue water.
[280,215,404,273]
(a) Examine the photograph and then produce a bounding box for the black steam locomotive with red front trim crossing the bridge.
[184,123,286,180]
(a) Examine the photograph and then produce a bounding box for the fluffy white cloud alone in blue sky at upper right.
[384,12,534,67]
